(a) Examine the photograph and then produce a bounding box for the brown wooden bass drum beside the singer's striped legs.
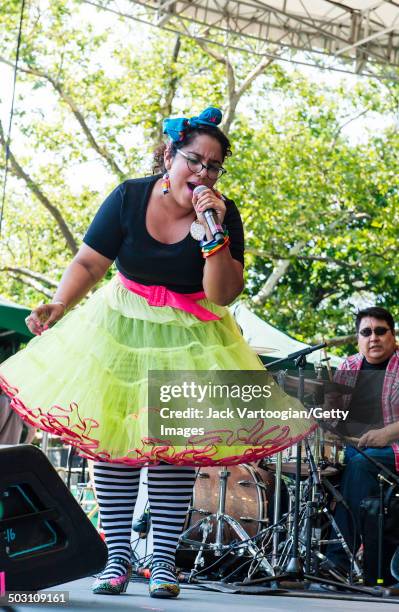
[182,464,269,544]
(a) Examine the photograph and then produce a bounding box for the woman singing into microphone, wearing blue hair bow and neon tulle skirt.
[0,107,311,597]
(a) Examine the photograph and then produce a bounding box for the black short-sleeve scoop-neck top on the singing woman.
[83,175,244,293]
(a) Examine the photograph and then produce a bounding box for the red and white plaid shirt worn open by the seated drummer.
[334,350,399,473]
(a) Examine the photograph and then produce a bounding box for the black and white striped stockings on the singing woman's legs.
[94,461,196,578]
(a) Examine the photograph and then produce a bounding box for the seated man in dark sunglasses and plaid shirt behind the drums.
[327,307,399,569]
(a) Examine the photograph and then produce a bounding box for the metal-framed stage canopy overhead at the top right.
[83,0,399,79]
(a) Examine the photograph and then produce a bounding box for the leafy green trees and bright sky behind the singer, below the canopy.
[0,0,399,350]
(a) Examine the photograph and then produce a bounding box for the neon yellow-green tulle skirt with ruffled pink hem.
[0,276,315,466]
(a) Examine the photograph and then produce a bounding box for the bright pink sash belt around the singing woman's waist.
[118,272,220,321]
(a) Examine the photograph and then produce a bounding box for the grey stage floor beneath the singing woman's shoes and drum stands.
[8,578,399,612]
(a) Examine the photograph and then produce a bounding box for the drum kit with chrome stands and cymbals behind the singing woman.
[72,345,399,594]
